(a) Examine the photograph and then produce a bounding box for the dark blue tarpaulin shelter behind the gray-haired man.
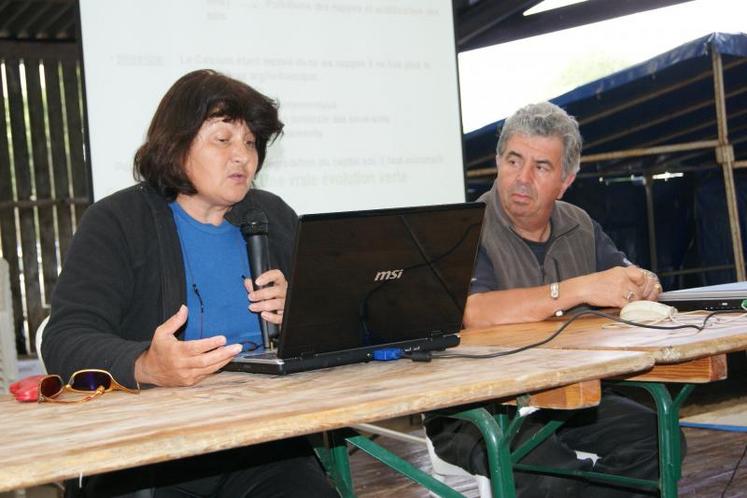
[465,33,747,288]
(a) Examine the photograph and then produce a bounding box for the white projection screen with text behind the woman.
[80,0,464,213]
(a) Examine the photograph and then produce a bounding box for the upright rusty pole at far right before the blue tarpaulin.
[711,49,745,281]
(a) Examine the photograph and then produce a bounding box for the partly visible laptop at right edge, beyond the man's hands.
[659,282,747,311]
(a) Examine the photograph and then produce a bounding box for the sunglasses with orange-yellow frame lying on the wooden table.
[39,369,140,403]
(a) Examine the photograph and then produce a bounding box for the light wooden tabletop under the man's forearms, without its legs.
[461,313,747,364]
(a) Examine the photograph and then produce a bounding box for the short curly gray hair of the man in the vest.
[496,102,582,180]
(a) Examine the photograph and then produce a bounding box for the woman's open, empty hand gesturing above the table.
[135,305,241,386]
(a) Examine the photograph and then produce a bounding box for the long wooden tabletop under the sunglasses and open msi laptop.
[0,348,653,491]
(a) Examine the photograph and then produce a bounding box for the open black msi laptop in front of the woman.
[224,203,485,375]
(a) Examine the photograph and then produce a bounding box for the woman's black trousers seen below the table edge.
[65,438,339,498]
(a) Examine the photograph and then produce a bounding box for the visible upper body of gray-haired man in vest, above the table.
[464,102,661,327]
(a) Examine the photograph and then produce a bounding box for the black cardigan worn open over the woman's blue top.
[41,183,297,386]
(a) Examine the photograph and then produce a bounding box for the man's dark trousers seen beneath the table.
[426,392,685,498]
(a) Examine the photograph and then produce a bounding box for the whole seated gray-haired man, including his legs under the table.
[426,102,676,498]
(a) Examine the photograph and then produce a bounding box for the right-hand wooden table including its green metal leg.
[462,313,747,498]
